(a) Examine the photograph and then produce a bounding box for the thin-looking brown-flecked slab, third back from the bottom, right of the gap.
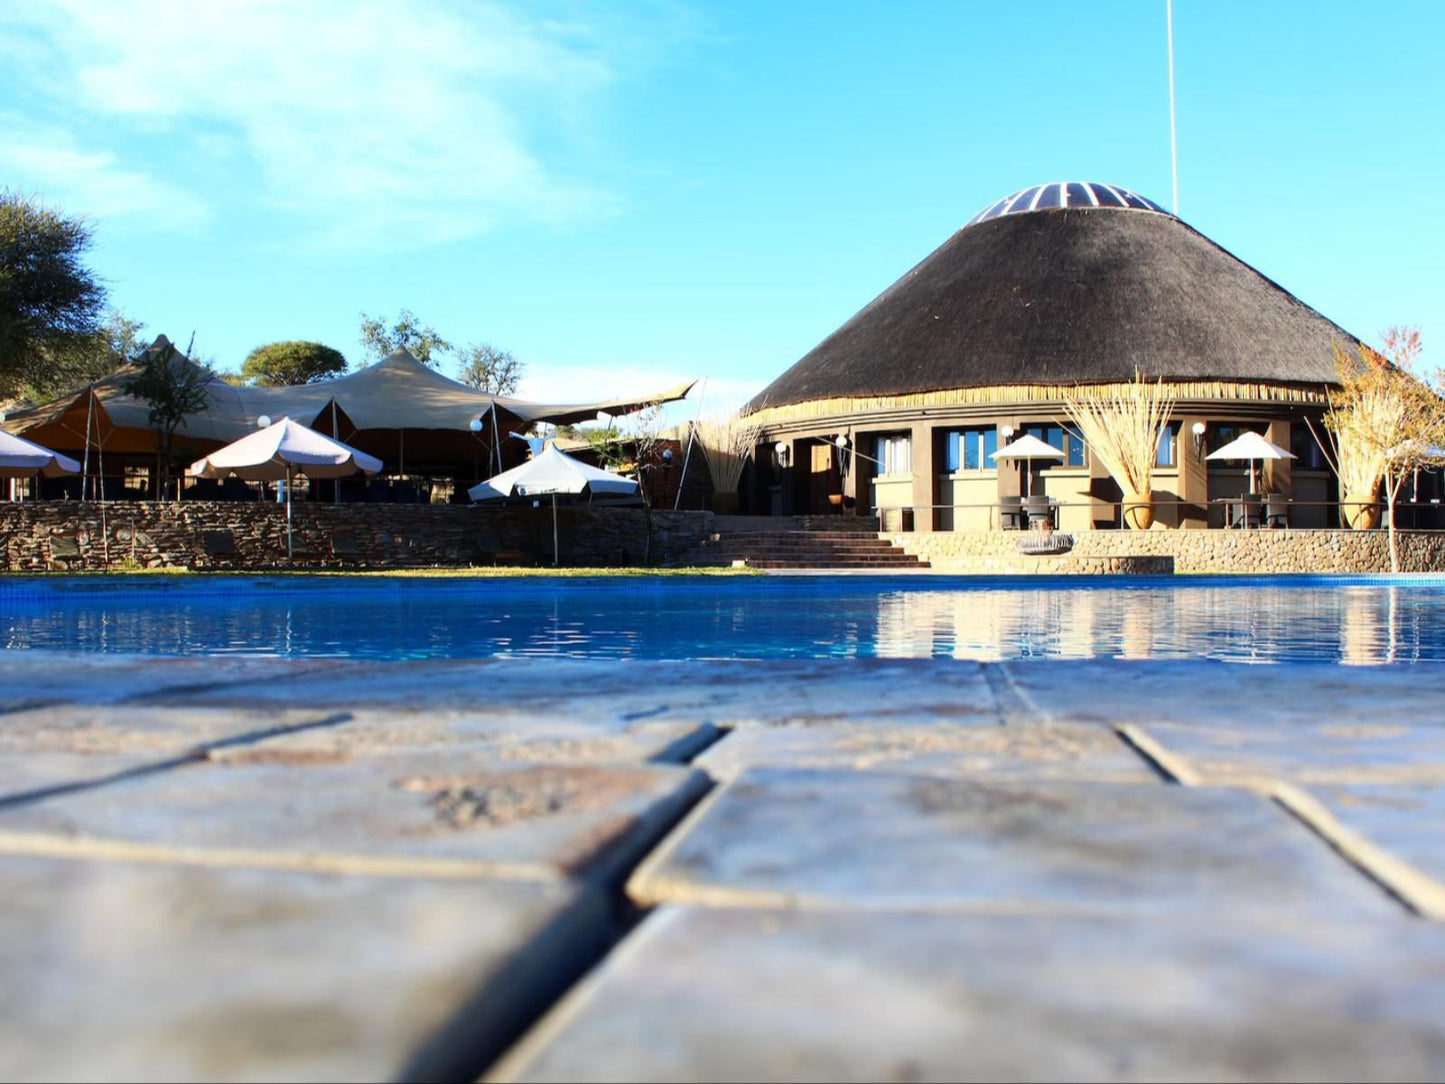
[696,723,1159,783]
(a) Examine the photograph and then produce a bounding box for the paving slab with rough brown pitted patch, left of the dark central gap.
[0,747,707,880]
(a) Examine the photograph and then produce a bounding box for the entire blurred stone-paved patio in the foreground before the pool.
[0,652,1445,1081]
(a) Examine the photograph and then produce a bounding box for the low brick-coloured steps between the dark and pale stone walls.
[679,520,928,572]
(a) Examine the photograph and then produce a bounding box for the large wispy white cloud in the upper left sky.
[0,0,687,247]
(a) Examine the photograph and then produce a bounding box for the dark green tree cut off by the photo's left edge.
[0,189,105,396]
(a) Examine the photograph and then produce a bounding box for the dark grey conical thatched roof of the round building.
[744,185,1355,413]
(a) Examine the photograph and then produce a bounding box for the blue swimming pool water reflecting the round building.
[0,575,1445,665]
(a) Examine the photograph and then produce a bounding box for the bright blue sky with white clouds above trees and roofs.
[0,0,1445,413]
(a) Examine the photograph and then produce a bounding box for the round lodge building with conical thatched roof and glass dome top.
[743,182,1404,530]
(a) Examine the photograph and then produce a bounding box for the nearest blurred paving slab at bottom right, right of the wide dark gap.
[488,908,1445,1081]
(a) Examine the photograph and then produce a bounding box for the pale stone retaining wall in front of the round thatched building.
[884,530,1445,574]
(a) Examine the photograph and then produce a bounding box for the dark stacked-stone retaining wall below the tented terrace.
[0,502,712,571]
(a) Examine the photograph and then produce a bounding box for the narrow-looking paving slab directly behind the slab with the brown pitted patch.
[217,705,718,765]
